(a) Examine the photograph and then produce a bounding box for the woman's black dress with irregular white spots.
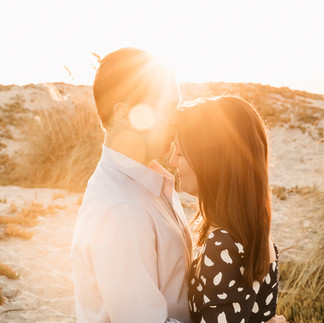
[189,229,278,323]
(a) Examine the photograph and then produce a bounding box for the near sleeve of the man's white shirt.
[91,204,182,323]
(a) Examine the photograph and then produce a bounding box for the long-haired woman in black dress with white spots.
[170,96,278,323]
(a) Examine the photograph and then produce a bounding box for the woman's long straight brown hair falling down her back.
[178,96,271,285]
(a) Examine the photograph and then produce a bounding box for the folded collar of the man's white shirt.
[101,145,174,197]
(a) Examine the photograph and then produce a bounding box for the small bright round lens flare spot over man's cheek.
[128,104,155,131]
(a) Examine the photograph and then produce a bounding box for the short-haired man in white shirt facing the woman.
[72,48,192,323]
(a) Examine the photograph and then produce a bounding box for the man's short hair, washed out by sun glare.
[93,47,179,128]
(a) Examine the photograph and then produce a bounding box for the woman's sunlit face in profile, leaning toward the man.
[169,136,199,196]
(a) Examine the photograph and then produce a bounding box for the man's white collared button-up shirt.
[71,145,192,323]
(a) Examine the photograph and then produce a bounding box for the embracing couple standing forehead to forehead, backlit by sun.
[71,48,285,323]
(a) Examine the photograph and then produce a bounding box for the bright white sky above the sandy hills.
[0,0,324,94]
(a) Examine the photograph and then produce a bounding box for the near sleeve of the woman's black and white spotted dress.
[199,230,256,323]
